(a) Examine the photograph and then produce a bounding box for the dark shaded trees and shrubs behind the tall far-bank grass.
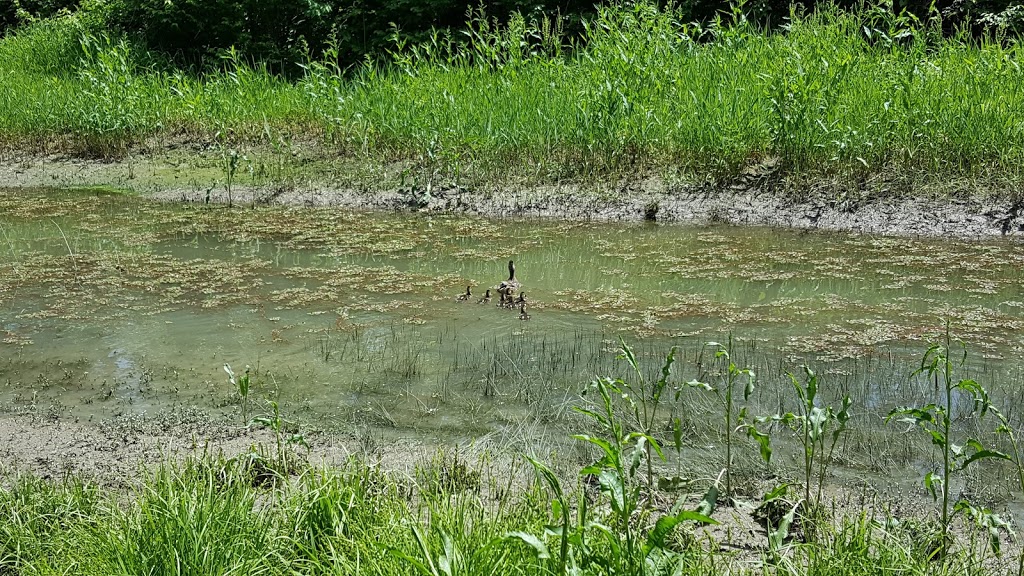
[6,0,1024,76]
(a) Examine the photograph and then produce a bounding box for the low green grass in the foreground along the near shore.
[0,448,958,576]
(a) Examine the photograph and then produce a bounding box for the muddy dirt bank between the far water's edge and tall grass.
[0,145,1024,239]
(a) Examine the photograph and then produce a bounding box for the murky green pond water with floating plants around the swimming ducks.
[0,189,1024,434]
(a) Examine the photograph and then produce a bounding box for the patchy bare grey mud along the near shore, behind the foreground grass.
[0,411,1020,574]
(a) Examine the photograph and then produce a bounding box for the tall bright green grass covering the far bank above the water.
[0,4,1024,192]
